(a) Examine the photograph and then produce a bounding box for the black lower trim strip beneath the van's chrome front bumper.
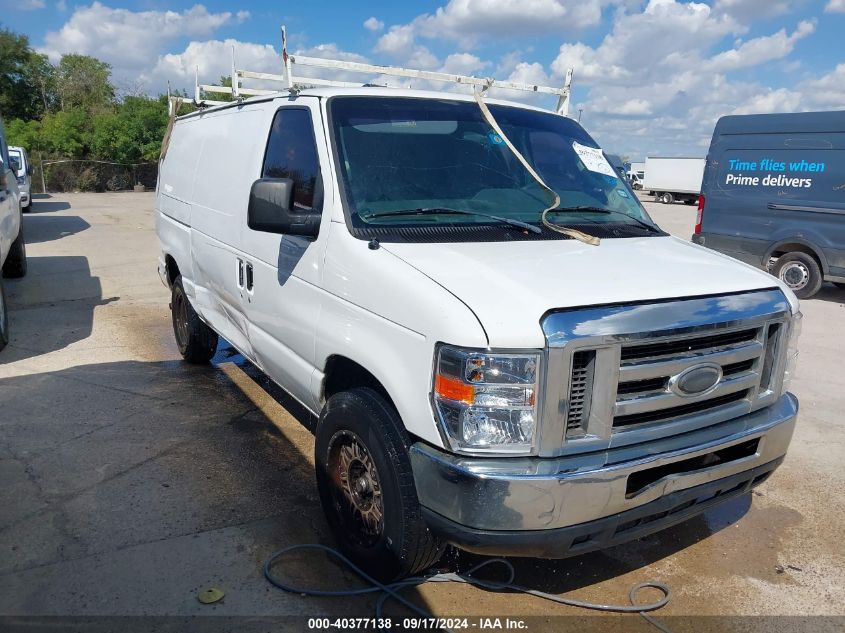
[423,457,783,558]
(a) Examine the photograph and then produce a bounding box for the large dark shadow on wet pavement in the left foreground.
[0,355,428,616]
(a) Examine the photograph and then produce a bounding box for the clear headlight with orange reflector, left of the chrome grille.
[433,345,541,455]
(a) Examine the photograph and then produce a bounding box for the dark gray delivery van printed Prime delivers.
[692,111,845,299]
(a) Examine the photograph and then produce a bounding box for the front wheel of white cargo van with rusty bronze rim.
[315,388,444,581]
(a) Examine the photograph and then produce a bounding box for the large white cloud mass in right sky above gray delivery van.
[528,0,832,158]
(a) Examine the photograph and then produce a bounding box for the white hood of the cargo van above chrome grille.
[381,237,792,348]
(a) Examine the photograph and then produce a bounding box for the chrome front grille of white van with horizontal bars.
[538,290,791,455]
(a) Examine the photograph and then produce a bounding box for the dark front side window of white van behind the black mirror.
[261,108,323,211]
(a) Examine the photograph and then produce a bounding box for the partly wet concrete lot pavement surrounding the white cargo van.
[0,193,845,630]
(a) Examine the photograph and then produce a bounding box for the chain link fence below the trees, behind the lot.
[32,158,158,193]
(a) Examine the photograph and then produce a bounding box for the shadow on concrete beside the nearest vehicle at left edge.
[0,255,116,364]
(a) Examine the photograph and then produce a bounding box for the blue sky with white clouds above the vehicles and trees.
[0,0,845,160]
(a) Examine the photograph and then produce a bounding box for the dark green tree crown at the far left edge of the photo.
[0,29,54,120]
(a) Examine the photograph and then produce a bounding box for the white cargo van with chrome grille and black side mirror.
[156,74,800,577]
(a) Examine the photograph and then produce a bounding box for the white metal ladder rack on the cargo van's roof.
[178,26,573,116]
